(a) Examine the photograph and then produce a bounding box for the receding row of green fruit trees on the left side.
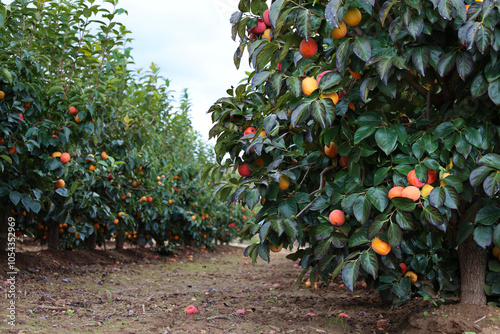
[0,0,253,253]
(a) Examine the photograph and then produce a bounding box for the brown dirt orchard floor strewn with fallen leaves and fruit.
[0,241,500,334]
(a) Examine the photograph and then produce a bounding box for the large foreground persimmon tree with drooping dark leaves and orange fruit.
[204,0,500,304]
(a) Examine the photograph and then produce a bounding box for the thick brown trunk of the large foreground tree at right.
[458,236,488,305]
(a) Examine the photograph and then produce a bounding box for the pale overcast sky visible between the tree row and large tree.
[117,0,250,140]
